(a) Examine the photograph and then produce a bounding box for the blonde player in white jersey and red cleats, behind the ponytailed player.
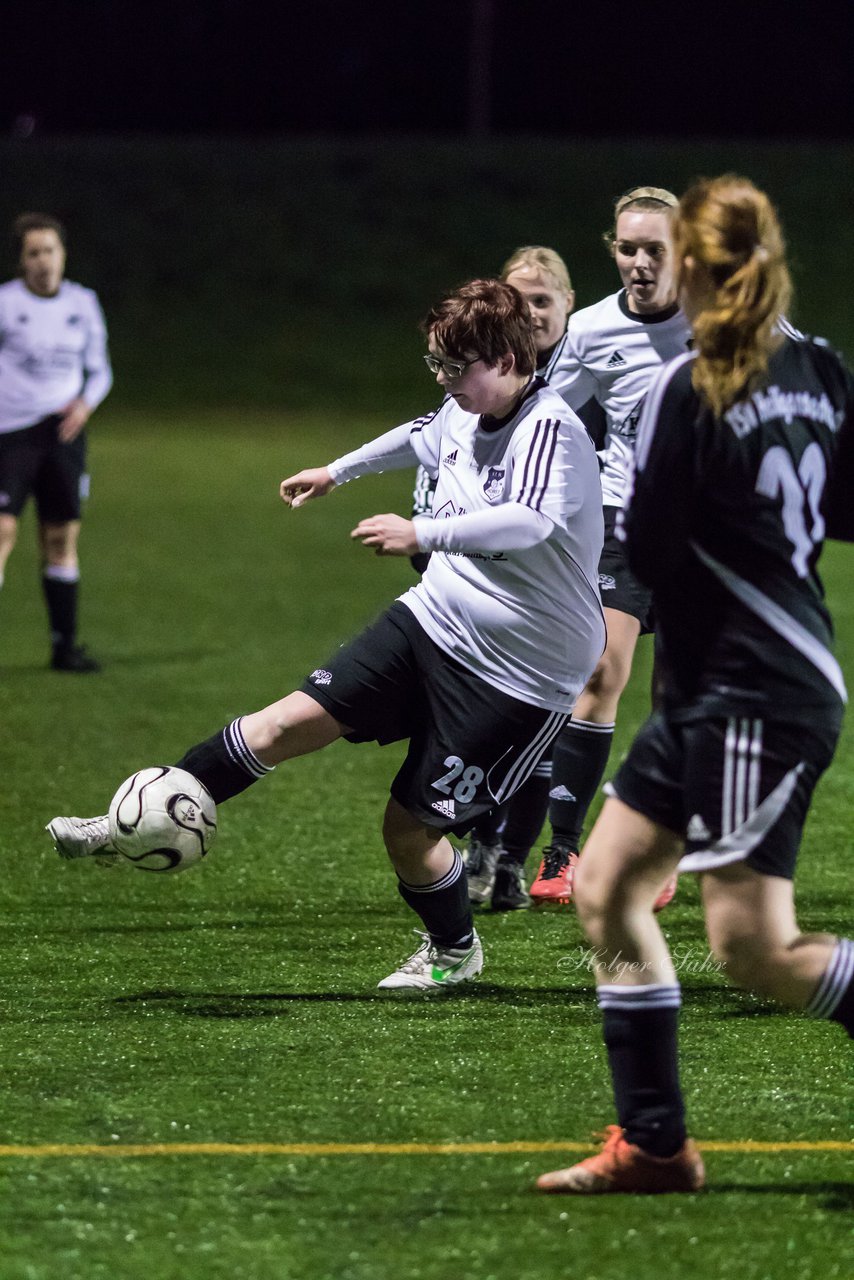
[530,187,690,905]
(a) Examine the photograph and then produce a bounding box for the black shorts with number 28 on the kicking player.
[302,602,568,836]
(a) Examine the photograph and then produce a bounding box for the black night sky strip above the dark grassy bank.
[0,0,854,138]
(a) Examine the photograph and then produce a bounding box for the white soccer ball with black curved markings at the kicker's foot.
[109,764,216,872]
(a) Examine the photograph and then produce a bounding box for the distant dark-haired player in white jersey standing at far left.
[0,214,113,675]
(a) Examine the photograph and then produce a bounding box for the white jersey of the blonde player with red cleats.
[549,289,691,507]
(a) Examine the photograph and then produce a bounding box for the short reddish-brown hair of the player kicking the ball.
[421,280,536,378]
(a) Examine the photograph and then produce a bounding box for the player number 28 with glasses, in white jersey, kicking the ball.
[49,280,604,991]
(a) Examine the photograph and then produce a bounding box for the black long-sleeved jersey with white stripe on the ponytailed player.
[622,330,854,723]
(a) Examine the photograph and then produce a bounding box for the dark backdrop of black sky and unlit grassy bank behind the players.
[0,0,854,419]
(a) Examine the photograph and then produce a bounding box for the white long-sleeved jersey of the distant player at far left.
[0,280,113,433]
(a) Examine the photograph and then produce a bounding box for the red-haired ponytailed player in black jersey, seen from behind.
[538,177,854,1194]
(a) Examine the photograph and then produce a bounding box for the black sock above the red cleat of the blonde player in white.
[548,719,613,851]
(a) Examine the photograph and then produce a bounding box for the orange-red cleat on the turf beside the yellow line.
[536,1124,705,1196]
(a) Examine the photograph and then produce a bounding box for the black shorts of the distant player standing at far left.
[0,413,88,525]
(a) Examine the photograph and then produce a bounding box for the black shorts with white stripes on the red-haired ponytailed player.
[606,712,840,879]
